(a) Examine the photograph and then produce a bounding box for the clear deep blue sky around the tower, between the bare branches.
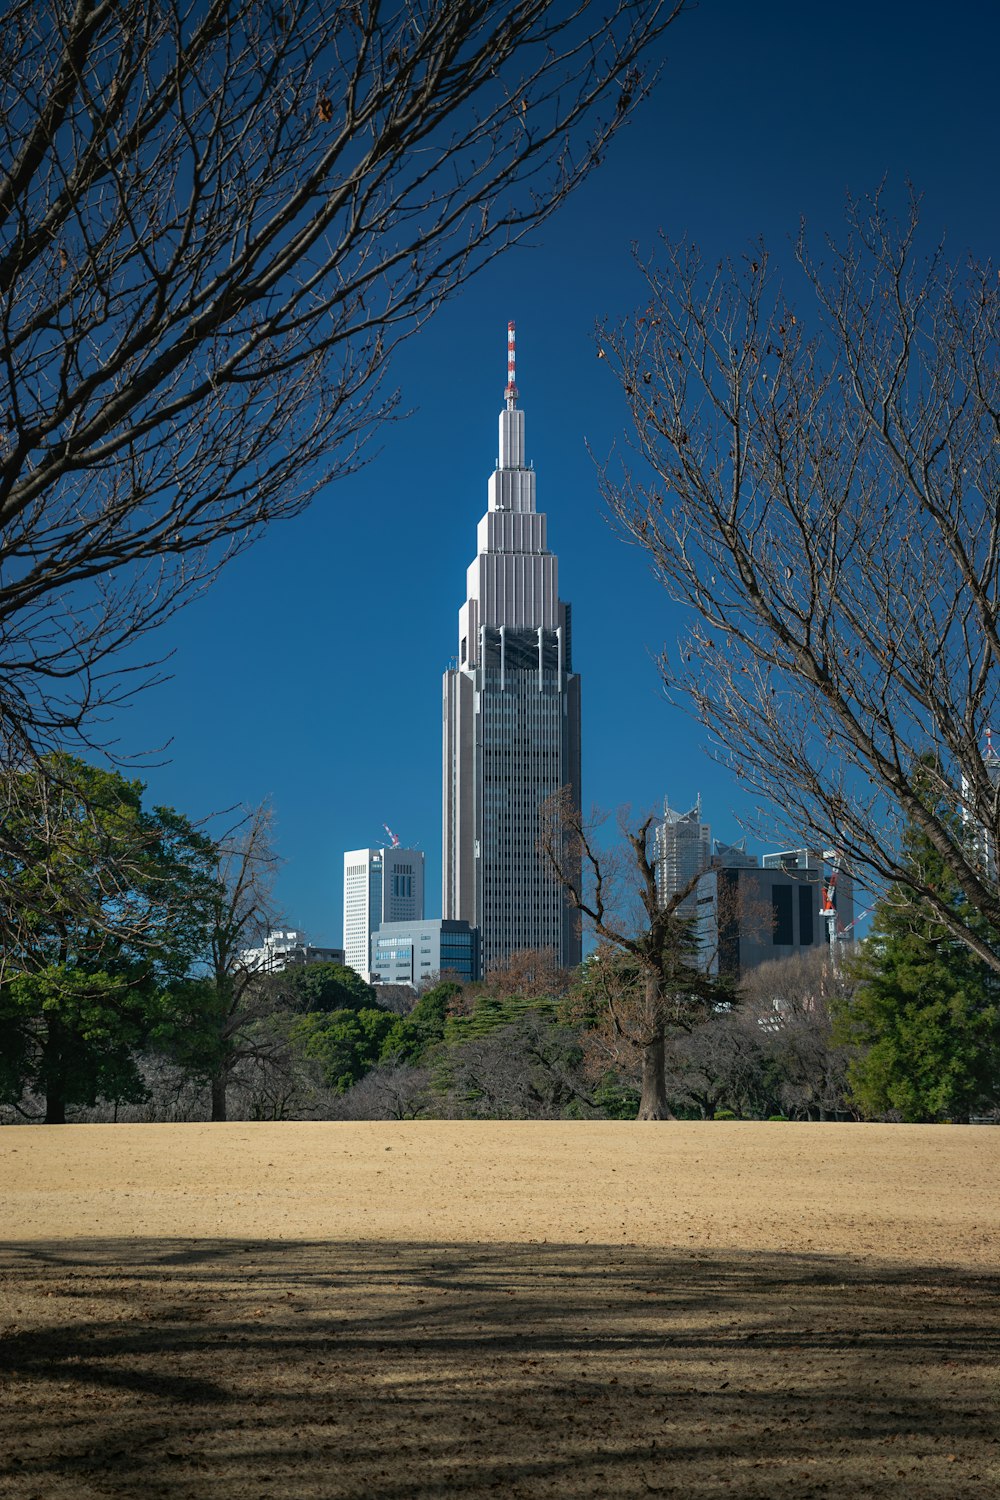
[101,0,1000,942]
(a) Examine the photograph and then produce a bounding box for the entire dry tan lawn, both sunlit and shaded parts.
[0,1124,1000,1500]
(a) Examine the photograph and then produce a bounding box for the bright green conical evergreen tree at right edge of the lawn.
[838,780,1000,1122]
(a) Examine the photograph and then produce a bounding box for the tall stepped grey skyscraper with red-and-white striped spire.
[442,323,580,974]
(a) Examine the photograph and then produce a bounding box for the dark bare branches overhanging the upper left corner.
[0,0,682,764]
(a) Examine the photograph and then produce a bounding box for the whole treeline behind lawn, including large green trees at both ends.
[0,758,1000,1124]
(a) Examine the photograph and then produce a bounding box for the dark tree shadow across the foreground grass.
[0,1239,1000,1500]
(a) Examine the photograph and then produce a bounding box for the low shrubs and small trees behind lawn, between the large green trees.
[4,953,1000,1122]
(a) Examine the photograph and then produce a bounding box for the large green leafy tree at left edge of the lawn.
[0,756,214,1125]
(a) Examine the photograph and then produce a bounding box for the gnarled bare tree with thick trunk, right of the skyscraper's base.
[540,788,724,1121]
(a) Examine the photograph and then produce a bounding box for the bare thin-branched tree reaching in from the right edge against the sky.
[601,195,1000,971]
